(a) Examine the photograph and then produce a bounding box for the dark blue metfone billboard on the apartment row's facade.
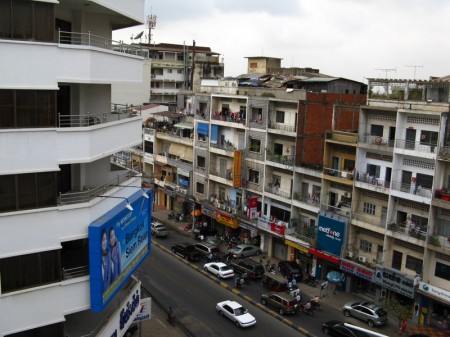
[316,214,347,256]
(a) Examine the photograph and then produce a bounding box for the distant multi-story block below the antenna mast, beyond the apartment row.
[142,41,224,107]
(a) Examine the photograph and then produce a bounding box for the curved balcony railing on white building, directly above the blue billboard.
[59,171,139,205]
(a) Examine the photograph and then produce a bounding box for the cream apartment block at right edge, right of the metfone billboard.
[344,78,450,329]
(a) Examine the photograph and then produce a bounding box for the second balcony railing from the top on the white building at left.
[58,104,142,128]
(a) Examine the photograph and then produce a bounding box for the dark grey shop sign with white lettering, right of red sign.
[374,267,414,298]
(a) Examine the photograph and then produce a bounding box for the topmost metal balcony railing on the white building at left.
[58,30,143,56]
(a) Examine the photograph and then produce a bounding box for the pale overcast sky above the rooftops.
[113,0,450,83]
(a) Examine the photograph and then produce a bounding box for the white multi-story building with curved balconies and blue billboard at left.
[0,0,151,336]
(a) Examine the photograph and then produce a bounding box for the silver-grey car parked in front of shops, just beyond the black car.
[342,301,388,327]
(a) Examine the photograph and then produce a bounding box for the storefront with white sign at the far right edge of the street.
[414,282,450,330]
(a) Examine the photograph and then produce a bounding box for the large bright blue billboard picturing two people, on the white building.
[89,190,152,312]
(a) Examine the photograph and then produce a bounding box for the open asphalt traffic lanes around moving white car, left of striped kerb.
[139,246,312,337]
